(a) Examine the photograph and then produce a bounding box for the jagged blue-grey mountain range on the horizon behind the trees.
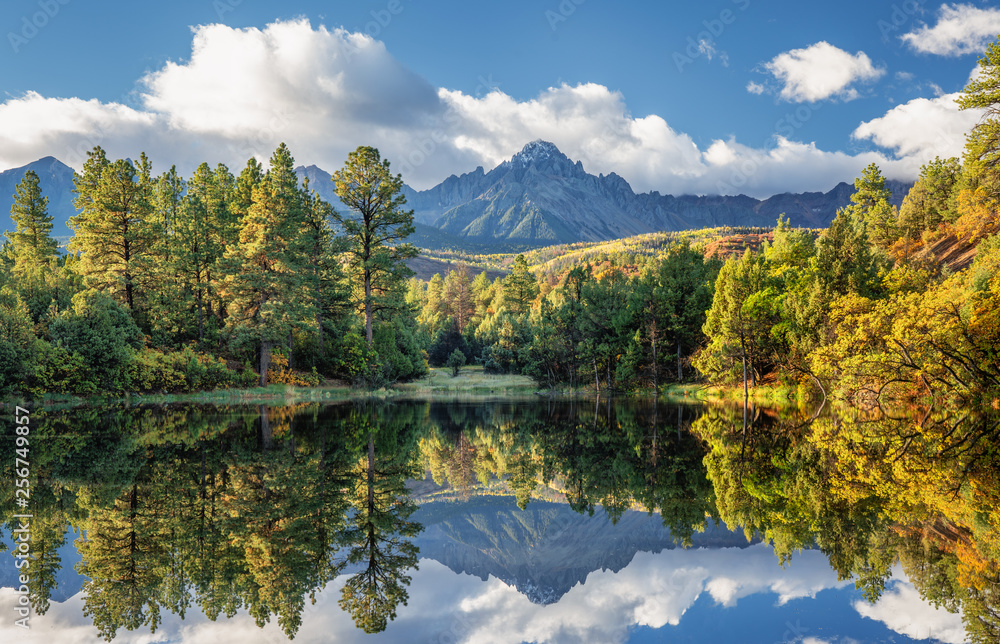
[0,141,912,249]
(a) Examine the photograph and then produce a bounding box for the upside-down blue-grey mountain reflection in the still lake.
[413,497,750,604]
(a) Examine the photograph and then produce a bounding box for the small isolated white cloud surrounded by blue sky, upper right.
[764,41,885,103]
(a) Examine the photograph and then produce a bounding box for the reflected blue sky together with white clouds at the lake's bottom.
[0,532,964,644]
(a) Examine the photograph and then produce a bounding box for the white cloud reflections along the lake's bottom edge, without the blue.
[0,545,964,644]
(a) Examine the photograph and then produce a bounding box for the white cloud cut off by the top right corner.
[900,4,1000,56]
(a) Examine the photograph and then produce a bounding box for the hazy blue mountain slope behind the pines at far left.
[0,157,76,244]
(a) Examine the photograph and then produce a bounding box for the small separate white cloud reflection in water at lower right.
[854,570,967,644]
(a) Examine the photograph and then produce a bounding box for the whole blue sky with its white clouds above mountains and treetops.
[0,0,1000,196]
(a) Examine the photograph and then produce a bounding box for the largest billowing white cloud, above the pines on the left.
[0,20,460,189]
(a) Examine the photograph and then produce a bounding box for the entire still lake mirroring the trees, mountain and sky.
[0,398,1000,644]
